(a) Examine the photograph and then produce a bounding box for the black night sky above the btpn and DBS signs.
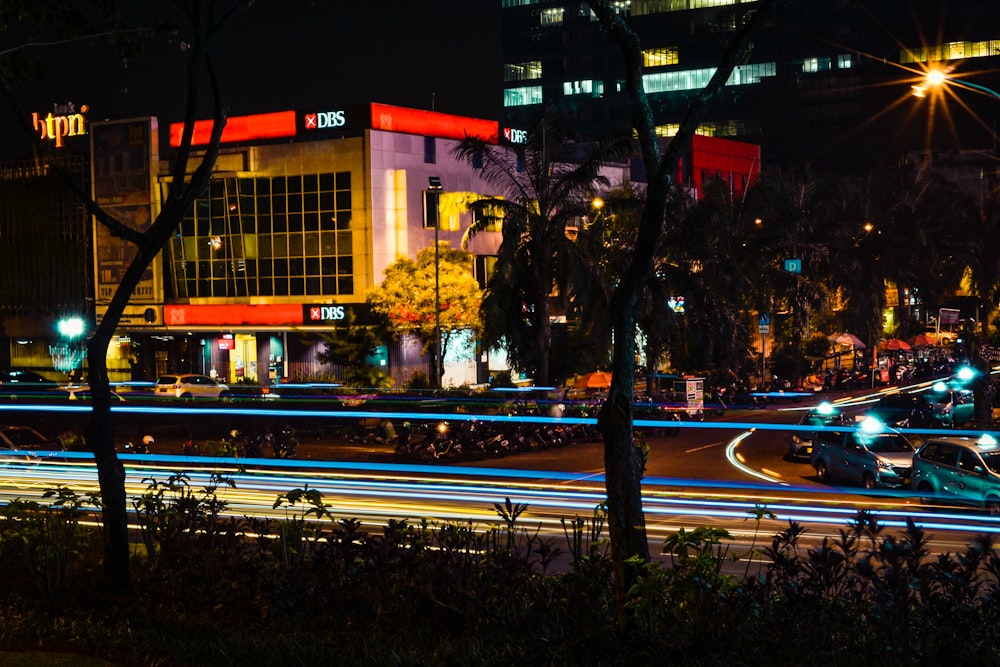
[0,0,502,160]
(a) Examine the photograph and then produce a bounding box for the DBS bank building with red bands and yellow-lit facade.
[90,104,500,385]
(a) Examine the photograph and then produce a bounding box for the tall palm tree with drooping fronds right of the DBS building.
[454,115,625,384]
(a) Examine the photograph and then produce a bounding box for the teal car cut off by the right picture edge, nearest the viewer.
[911,435,1000,516]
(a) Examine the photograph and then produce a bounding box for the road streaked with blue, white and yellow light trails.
[0,392,1000,564]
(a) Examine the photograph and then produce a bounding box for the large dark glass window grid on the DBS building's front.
[168,172,354,298]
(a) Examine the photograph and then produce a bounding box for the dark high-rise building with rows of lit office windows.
[502,0,1000,172]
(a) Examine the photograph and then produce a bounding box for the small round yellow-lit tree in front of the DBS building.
[368,241,482,384]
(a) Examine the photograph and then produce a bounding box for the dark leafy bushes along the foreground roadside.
[0,488,1000,667]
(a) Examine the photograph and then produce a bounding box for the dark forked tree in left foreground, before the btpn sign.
[0,0,252,591]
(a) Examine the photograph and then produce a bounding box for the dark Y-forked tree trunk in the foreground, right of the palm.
[588,0,777,623]
